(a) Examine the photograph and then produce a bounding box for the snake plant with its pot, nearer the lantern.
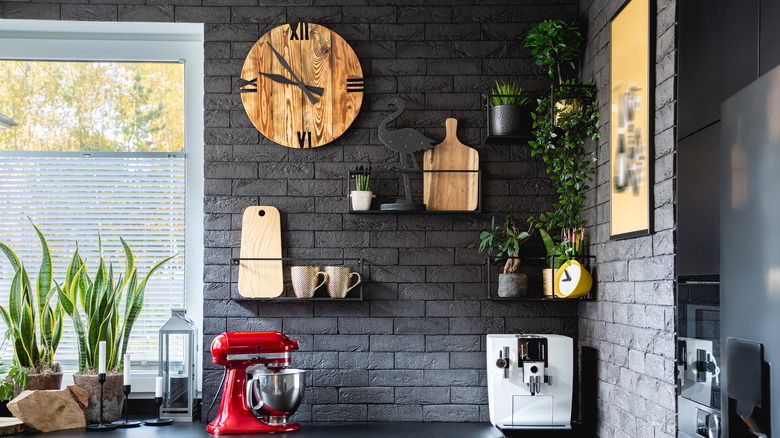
[55,238,174,423]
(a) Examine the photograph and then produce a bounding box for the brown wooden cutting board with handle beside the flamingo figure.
[423,119,479,211]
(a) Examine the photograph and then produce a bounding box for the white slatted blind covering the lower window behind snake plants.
[0,152,186,370]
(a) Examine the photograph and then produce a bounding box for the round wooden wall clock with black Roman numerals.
[240,22,363,148]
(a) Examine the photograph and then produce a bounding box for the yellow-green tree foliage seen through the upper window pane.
[0,60,184,152]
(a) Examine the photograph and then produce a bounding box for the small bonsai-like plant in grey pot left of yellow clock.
[479,215,533,298]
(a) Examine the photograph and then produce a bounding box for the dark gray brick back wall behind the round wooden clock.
[0,0,584,421]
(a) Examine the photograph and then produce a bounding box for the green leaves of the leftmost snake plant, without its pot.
[0,224,62,374]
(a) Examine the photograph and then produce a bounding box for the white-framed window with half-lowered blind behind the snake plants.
[0,20,203,382]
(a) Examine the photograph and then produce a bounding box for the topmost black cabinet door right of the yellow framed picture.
[677,0,760,138]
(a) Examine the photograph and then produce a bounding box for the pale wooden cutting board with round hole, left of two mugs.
[238,206,284,298]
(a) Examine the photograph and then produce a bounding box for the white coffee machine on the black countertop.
[487,335,574,434]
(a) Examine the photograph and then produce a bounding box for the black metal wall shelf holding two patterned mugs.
[229,257,368,303]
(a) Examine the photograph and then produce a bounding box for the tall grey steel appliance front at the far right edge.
[720,63,780,438]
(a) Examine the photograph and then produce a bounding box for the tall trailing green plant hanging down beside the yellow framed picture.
[525,20,599,250]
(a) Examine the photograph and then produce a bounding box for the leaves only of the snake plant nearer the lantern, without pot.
[55,237,174,374]
